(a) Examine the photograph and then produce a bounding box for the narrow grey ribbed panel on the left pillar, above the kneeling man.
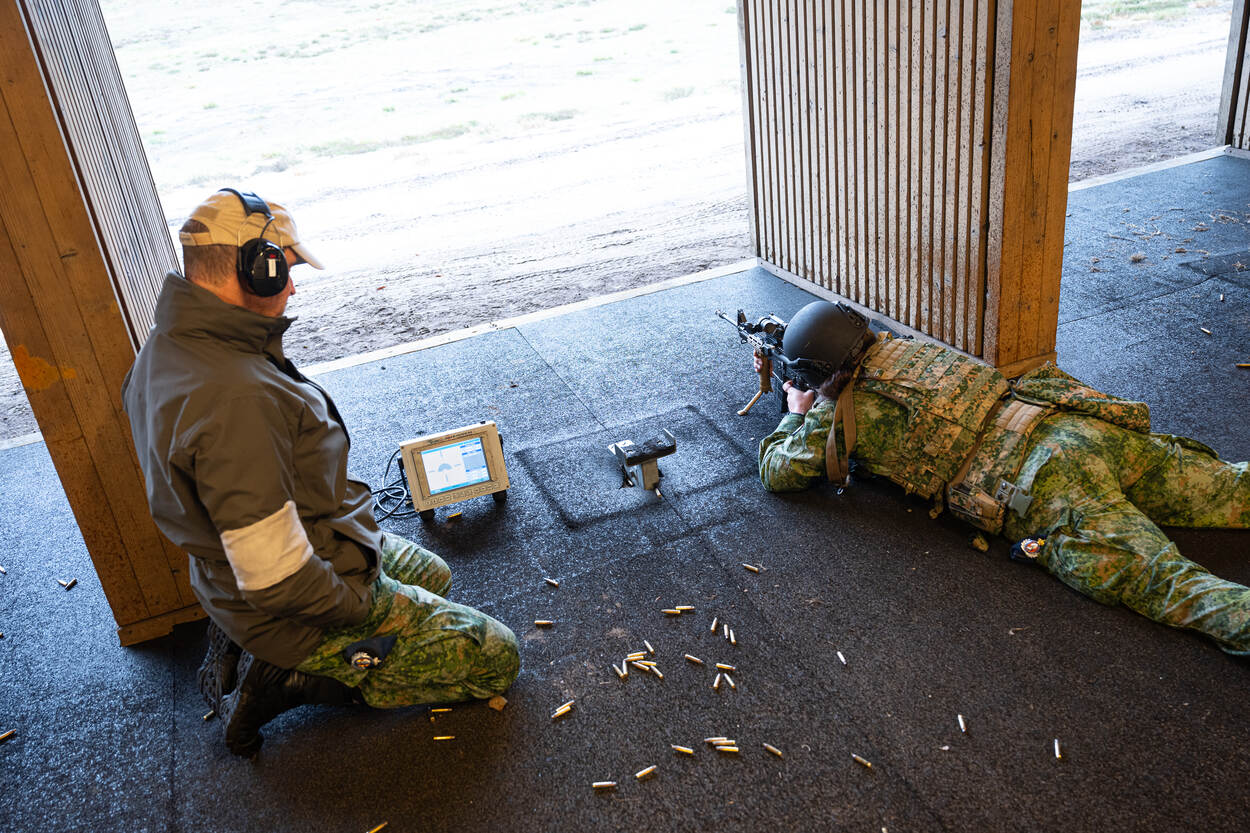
[19,0,178,349]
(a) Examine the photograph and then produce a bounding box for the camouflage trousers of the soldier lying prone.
[1004,415,1250,655]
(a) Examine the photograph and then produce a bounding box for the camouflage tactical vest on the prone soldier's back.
[855,339,1009,498]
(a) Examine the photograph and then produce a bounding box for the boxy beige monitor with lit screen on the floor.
[399,422,509,522]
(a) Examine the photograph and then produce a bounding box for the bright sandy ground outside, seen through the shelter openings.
[0,0,1230,442]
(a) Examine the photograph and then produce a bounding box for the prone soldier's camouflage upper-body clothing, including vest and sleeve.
[759,340,1150,532]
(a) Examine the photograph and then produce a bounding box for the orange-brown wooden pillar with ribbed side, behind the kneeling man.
[0,0,203,644]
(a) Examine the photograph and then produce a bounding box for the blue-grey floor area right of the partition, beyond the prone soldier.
[1059,156,1250,455]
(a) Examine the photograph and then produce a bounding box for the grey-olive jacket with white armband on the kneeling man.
[123,273,381,668]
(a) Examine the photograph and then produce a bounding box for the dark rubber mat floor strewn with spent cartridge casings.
[0,158,1250,833]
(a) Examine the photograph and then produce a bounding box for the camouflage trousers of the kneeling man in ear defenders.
[296,533,520,708]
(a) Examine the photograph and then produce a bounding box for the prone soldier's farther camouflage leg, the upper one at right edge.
[1121,434,1250,529]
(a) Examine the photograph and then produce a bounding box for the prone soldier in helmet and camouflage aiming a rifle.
[735,301,1250,655]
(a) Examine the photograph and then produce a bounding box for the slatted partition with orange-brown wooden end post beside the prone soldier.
[739,0,1080,366]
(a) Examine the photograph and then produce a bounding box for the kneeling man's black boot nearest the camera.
[220,652,364,758]
